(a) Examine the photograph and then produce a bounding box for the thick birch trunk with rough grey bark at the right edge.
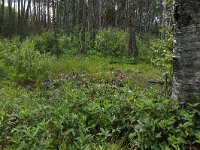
[172,0,200,101]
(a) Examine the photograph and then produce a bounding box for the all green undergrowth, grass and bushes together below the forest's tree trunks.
[0,29,200,150]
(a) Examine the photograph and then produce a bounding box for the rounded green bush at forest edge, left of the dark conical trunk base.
[95,28,128,56]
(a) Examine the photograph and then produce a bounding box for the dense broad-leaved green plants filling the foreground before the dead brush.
[0,81,200,150]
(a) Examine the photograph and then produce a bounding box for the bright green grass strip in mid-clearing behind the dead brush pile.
[50,55,162,88]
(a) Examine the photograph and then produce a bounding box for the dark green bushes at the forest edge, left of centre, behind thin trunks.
[29,31,90,55]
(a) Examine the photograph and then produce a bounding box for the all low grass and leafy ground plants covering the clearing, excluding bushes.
[0,55,200,150]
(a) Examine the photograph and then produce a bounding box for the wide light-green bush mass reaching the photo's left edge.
[1,40,51,84]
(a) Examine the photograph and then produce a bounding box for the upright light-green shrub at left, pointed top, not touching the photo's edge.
[13,40,51,83]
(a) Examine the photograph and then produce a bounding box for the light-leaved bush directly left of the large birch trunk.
[137,28,173,71]
